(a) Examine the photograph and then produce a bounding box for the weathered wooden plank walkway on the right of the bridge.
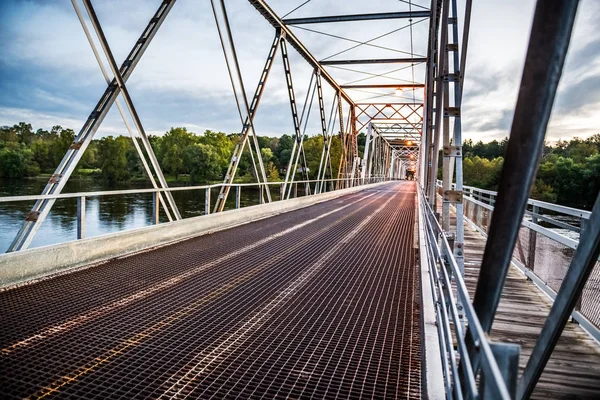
[465,217,600,399]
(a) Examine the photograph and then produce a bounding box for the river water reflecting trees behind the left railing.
[0,178,279,253]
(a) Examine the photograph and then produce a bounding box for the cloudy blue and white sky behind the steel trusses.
[0,0,600,141]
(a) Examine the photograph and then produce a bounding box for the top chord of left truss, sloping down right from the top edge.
[248,0,354,104]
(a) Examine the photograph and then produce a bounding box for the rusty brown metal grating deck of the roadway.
[0,182,421,399]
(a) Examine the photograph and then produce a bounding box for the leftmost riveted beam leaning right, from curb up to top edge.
[7,0,176,252]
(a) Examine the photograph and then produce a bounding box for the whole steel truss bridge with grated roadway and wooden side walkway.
[0,0,600,399]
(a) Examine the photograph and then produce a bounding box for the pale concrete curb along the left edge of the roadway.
[0,181,389,287]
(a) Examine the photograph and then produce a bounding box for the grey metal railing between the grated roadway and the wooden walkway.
[419,186,520,399]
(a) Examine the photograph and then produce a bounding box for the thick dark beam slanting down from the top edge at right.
[468,0,578,366]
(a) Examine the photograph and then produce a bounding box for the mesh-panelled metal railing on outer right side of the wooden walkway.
[438,181,600,341]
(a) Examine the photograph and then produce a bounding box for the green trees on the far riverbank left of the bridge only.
[0,122,358,184]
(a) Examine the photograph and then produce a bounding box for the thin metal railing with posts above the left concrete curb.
[0,176,389,252]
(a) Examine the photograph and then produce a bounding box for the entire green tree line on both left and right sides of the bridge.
[0,122,600,209]
